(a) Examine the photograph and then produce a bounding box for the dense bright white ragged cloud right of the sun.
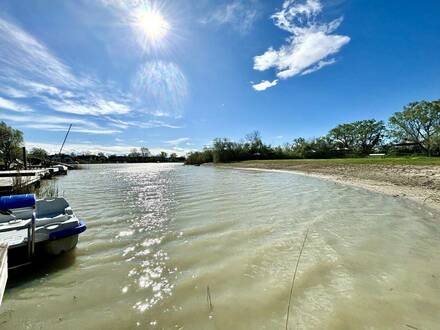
[253,0,350,91]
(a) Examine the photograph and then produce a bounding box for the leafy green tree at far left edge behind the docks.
[0,122,23,168]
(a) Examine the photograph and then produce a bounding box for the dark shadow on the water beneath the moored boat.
[6,249,76,289]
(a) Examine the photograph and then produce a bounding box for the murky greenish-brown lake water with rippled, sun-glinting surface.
[0,164,440,329]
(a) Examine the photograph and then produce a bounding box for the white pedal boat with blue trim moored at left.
[0,194,87,266]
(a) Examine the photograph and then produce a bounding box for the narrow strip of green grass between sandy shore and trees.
[235,156,440,166]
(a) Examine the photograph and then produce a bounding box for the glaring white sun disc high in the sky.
[136,10,170,42]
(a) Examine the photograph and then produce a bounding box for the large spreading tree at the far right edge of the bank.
[389,100,440,156]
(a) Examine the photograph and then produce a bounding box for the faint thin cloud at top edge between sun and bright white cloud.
[200,0,260,34]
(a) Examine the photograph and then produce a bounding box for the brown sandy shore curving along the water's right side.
[220,161,440,211]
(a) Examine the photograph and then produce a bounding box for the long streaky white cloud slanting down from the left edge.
[0,17,131,120]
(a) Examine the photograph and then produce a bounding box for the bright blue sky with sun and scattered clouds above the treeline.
[0,0,440,154]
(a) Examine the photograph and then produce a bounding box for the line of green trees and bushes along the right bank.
[186,100,440,165]
